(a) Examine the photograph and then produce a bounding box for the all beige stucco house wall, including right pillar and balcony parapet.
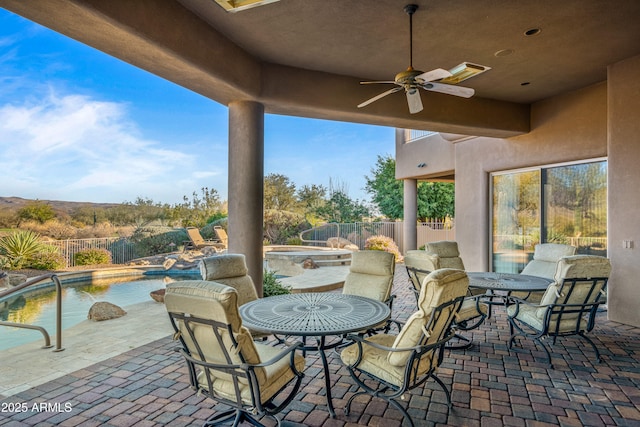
[396,57,640,326]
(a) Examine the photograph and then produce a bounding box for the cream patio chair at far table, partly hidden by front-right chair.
[404,251,489,350]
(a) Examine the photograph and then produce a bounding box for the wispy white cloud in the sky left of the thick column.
[0,91,226,203]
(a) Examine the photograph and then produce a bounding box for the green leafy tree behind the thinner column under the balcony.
[365,156,455,221]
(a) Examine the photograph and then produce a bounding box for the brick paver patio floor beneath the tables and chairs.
[0,266,640,427]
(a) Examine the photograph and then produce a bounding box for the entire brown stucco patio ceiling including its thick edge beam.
[0,0,640,136]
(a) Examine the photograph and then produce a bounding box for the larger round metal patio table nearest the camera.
[240,292,391,418]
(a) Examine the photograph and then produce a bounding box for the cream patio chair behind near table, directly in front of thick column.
[199,254,270,339]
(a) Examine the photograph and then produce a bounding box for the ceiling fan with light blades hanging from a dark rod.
[358,4,490,114]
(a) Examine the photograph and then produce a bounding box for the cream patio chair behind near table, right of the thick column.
[342,251,396,333]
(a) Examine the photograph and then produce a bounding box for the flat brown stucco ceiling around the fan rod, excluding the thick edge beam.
[181,0,640,103]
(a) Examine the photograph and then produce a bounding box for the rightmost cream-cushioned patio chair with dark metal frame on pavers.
[507,255,611,368]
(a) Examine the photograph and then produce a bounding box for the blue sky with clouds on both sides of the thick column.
[0,9,395,204]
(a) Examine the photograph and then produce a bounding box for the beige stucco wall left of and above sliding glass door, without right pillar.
[455,83,607,270]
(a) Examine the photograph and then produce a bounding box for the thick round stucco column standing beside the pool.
[228,101,264,296]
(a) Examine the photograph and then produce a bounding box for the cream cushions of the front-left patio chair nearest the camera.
[165,281,305,404]
